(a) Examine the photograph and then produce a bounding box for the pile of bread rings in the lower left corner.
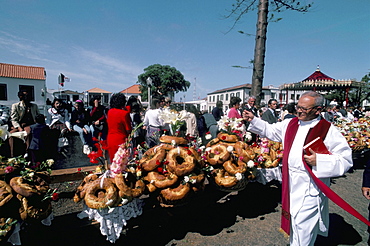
[0,172,52,225]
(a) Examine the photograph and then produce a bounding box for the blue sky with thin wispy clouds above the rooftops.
[0,0,370,101]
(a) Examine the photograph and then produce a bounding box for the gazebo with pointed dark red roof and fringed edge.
[280,66,364,105]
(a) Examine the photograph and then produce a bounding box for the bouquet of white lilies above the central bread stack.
[158,108,190,136]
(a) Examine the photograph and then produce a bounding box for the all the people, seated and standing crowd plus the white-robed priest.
[2,91,370,245]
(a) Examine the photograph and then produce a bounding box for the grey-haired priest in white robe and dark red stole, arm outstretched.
[243,91,353,246]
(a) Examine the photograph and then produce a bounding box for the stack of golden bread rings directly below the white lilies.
[138,136,205,207]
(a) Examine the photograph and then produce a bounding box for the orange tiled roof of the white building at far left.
[0,63,46,80]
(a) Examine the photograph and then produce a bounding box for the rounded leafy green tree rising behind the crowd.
[137,64,190,100]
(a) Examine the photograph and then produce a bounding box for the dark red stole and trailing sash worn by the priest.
[281,117,370,235]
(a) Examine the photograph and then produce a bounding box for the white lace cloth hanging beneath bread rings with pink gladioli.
[77,198,144,243]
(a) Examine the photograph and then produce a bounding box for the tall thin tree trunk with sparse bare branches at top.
[226,0,311,105]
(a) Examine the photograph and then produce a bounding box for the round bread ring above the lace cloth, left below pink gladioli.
[85,178,118,209]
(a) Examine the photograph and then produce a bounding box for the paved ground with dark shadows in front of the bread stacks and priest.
[9,161,368,246]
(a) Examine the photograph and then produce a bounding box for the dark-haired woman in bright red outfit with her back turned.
[107,93,132,162]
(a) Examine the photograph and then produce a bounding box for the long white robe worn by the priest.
[248,117,353,245]
